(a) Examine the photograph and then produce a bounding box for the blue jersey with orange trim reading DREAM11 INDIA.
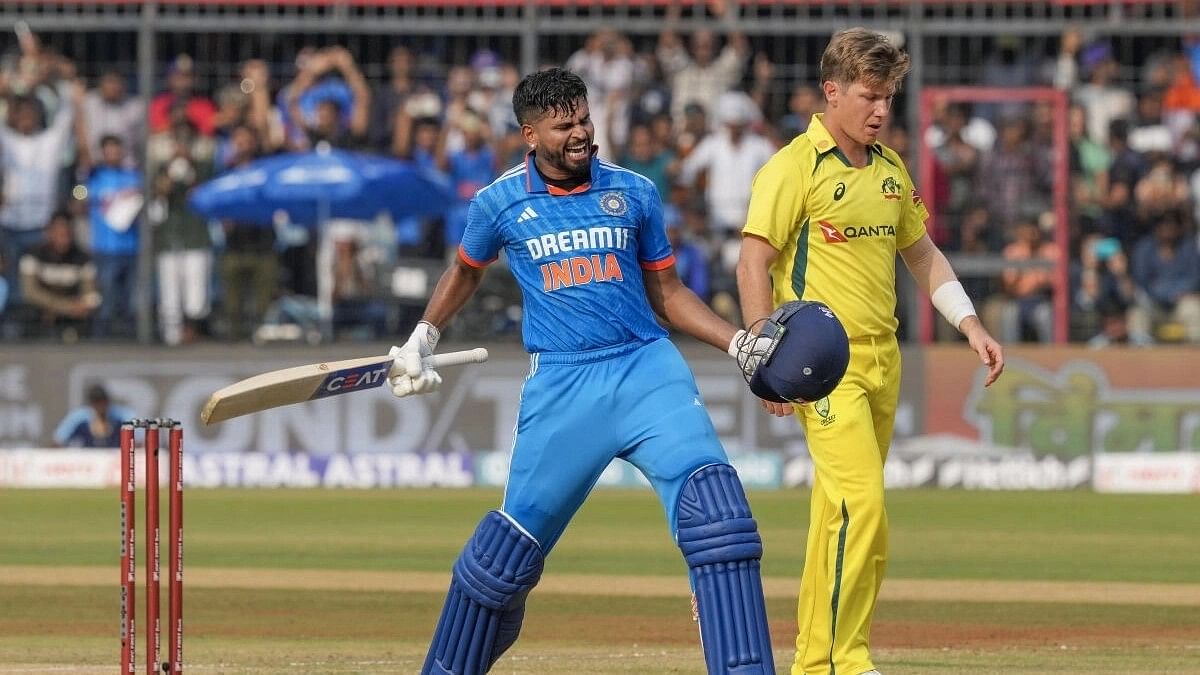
[458,153,674,352]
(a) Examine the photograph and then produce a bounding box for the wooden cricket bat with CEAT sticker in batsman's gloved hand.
[200,347,487,424]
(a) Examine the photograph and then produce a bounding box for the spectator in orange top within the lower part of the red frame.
[984,219,1058,342]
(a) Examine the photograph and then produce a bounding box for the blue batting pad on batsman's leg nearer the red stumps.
[421,510,545,675]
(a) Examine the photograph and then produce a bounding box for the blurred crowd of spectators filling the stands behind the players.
[0,22,1200,346]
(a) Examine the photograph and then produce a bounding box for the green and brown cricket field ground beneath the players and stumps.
[0,489,1200,675]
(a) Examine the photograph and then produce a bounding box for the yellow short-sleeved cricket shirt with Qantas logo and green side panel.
[742,114,929,340]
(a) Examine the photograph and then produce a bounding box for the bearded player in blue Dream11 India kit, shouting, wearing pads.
[389,68,775,675]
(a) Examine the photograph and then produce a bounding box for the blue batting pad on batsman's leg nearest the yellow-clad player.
[678,464,775,675]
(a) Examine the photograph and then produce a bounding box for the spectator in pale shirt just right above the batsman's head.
[566,29,634,159]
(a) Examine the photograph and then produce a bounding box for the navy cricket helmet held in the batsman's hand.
[748,300,850,404]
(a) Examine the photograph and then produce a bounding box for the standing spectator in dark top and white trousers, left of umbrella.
[146,139,212,346]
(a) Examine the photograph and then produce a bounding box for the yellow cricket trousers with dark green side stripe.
[792,335,900,675]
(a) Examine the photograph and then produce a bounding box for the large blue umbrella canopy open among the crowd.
[190,142,452,227]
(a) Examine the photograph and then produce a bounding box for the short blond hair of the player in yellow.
[821,28,912,89]
